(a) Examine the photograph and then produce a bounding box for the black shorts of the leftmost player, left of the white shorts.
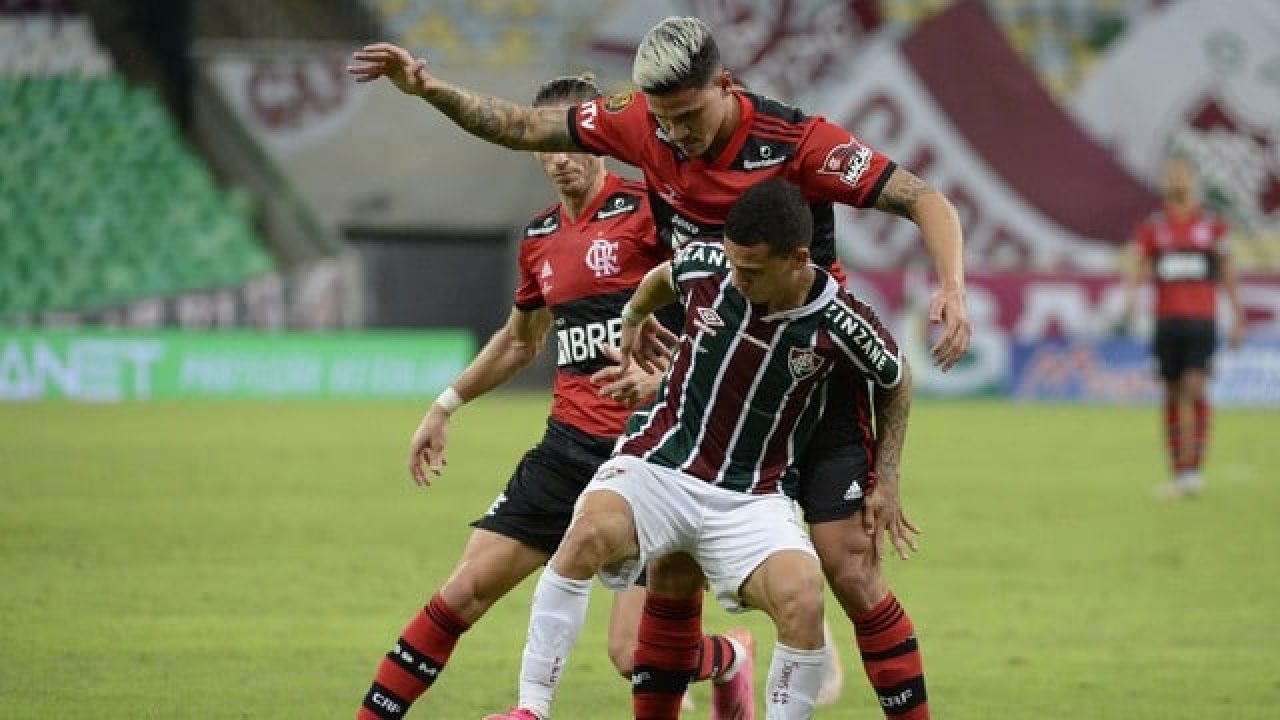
[471,420,613,555]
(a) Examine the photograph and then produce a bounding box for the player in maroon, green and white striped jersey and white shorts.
[488,178,914,720]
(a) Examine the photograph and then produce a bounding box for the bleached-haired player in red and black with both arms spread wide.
[351,18,952,720]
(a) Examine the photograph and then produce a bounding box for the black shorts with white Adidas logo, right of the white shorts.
[795,368,873,525]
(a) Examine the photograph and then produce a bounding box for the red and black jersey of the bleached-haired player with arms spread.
[568,91,895,281]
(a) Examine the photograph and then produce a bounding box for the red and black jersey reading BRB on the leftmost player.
[516,174,668,437]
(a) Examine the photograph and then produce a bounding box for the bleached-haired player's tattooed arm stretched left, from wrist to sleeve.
[422,85,581,152]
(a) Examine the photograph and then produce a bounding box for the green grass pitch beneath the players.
[0,395,1280,720]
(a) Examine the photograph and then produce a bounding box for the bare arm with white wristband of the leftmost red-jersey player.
[408,302,552,486]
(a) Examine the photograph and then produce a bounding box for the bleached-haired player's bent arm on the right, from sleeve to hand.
[876,167,973,370]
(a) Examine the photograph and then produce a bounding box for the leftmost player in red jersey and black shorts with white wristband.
[357,78,753,720]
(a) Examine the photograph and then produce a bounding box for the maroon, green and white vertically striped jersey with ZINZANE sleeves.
[620,242,902,495]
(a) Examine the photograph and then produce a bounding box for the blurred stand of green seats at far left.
[0,4,274,316]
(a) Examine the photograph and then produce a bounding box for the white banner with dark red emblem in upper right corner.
[1073,0,1280,236]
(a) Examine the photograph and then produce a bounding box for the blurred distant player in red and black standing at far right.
[1125,155,1244,497]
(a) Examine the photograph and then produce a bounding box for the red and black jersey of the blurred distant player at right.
[1134,202,1228,319]
